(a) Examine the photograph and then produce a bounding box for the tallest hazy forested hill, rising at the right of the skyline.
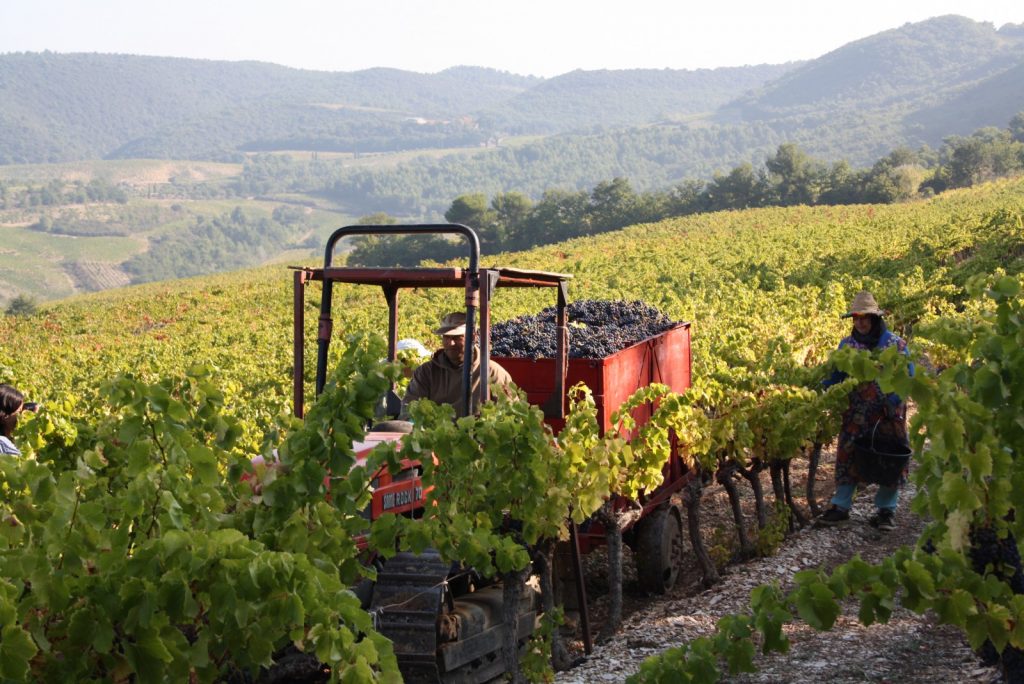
[721,15,1024,156]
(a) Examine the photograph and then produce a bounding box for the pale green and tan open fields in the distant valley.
[0,147,520,307]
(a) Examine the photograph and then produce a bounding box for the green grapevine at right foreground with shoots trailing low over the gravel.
[630,275,1024,682]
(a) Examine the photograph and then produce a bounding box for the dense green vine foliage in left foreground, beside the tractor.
[0,356,396,682]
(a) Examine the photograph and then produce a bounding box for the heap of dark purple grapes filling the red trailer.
[490,299,676,358]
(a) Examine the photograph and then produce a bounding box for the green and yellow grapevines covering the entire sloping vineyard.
[0,179,1024,682]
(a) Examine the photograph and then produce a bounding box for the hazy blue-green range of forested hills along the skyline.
[0,16,1024,171]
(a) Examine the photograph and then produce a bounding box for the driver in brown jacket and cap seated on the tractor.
[402,311,512,416]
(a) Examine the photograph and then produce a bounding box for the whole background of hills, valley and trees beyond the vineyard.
[0,16,1024,306]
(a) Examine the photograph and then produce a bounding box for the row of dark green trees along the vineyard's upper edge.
[348,112,1024,266]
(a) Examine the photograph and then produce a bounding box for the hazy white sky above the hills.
[0,0,1024,76]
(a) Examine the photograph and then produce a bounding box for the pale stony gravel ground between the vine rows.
[555,448,1000,684]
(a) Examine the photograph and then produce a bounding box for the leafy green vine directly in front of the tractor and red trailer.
[387,393,574,576]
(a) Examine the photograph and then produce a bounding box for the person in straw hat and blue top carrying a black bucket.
[818,291,913,530]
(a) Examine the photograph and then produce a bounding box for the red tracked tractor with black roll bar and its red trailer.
[294,224,692,682]
